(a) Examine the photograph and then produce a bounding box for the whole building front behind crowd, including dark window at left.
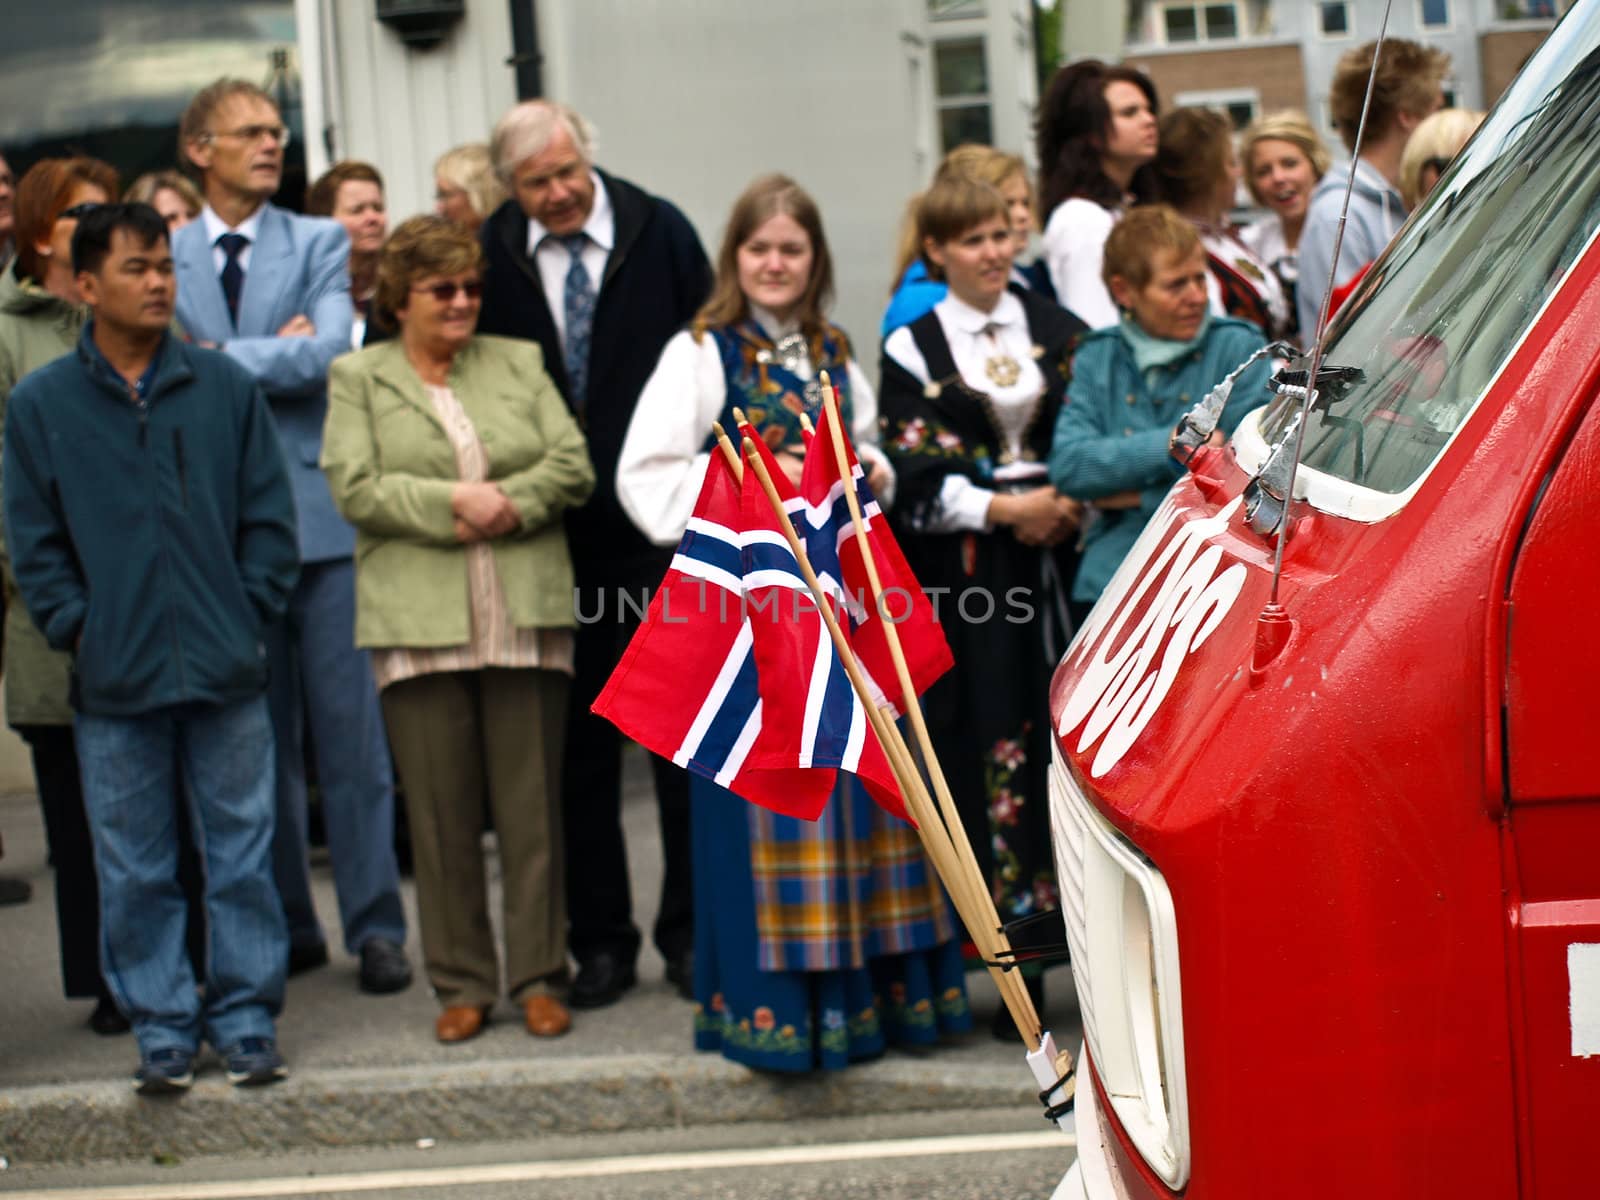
[0,0,1037,362]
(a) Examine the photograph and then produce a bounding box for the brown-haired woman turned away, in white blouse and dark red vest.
[1155,109,1294,339]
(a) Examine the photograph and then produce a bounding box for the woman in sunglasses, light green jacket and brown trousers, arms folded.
[322,216,594,1042]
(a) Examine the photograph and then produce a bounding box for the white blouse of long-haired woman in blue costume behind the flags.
[616,312,894,546]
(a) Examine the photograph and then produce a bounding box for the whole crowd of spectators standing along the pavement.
[0,30,1477,1094]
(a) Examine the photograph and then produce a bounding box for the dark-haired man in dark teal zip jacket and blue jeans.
[3,205,296,1094]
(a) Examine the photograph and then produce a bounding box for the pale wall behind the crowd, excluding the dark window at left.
[320,0,1037,361]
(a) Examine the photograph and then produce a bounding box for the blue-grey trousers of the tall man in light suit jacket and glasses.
[266,558,405,954]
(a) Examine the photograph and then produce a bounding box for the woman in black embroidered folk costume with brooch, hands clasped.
[883,179,1083,1037]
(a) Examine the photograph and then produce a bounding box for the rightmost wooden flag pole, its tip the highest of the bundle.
[821,371,1043,1045]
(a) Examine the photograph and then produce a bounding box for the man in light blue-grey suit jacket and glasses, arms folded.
[173,78,411,992]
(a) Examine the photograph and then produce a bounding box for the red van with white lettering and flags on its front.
[1050,0,1600,1200]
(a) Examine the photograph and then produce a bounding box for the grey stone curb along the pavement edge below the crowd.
[0,1054,1035,1166]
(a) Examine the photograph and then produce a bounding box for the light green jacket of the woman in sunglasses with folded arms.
[322,334,595,648]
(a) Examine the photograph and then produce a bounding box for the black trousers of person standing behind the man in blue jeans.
[25,725,205,1000]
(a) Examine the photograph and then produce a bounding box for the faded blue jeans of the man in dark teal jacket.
[75,698,288,1054]
